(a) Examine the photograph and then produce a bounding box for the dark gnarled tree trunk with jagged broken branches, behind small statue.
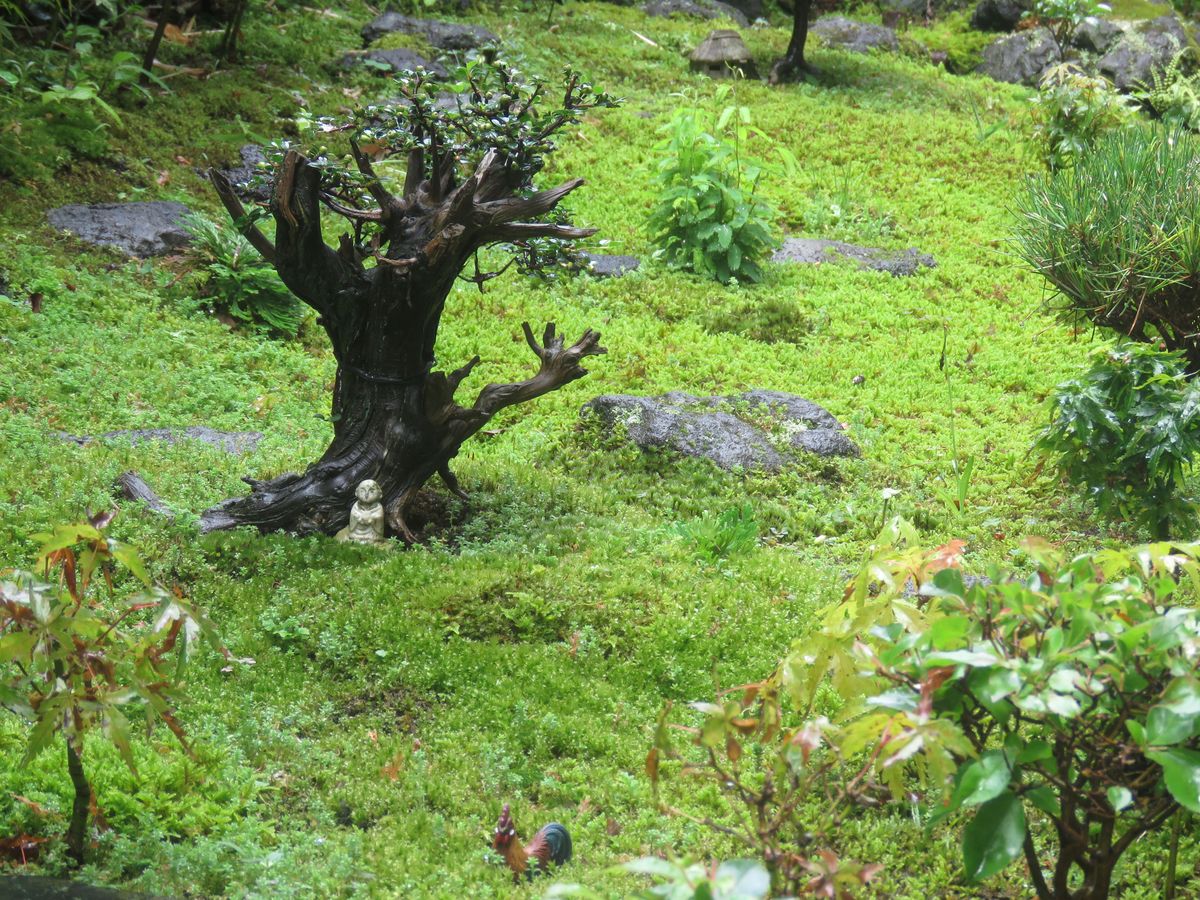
[200,144,605,540]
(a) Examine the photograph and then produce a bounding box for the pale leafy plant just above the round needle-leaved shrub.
[1030,64,1136,172]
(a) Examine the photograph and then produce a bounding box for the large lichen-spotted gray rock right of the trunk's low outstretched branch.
[582,390,860,473]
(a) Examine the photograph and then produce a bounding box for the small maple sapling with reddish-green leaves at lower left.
[0,516,221,865]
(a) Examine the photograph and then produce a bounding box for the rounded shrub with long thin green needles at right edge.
[1014,128,1200,373]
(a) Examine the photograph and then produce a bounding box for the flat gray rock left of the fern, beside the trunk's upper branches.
[46,200,191,257]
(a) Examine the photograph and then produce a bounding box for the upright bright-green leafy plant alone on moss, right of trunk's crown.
[647,85,786,284]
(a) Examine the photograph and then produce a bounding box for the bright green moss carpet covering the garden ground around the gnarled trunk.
[0,2,1198,898]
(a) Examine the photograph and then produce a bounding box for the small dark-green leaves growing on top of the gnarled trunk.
[260,59,620,284]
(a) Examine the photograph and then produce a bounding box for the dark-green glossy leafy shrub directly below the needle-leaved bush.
[1036,343,1200,540]
